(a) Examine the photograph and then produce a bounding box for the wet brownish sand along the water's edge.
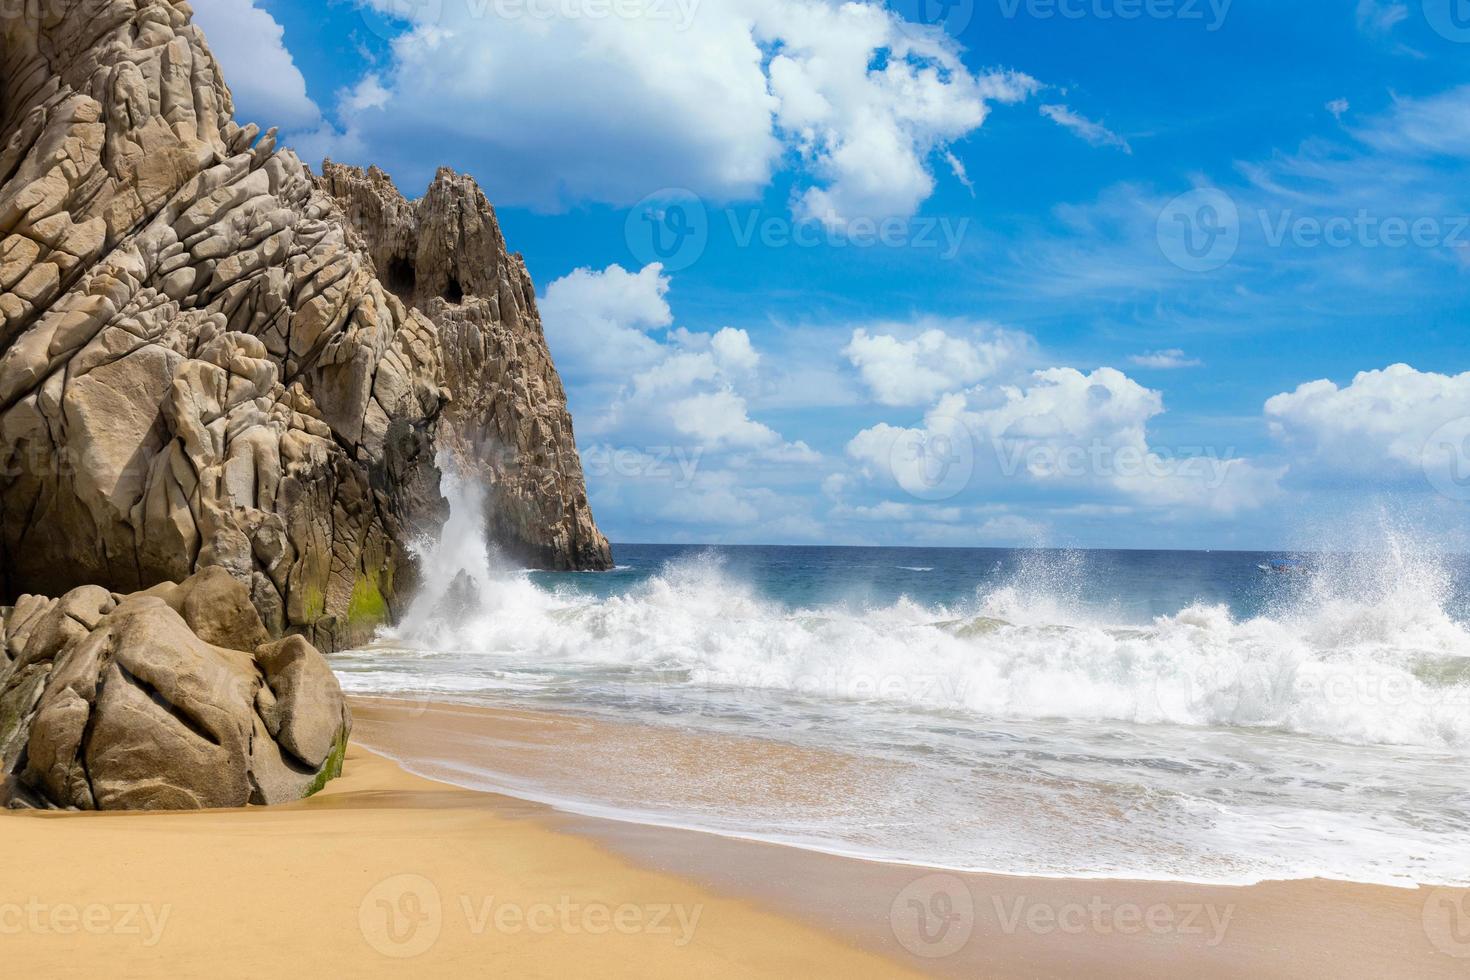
[351,698,1470,977]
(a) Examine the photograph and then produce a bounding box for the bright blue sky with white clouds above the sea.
[194,0,1470,548]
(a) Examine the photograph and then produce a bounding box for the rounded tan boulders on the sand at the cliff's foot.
[0,567,351,810]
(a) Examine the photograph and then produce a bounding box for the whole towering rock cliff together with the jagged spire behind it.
[0,0,609,649]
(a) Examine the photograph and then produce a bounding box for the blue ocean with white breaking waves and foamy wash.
[332,478,1470,886]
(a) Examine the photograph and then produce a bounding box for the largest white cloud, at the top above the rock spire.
[312,0,1038,223]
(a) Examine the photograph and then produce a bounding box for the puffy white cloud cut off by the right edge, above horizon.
[1266,364,1470,476]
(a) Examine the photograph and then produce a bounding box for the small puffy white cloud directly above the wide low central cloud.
[842,322,1032,406]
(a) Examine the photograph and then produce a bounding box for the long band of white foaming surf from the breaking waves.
[376,539,1470,748]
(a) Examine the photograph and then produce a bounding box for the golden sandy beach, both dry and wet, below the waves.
[0,701,1470,977]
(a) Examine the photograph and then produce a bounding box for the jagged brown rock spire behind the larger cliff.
[319,162,613,569]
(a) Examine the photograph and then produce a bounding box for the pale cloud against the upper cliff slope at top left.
[193,0,322,131]
